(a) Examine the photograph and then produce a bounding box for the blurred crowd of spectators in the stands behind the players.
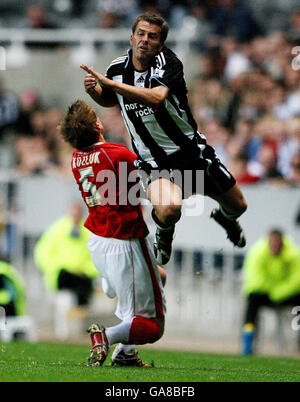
[0,0,300,186]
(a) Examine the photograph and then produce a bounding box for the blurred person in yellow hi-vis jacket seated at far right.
[242,229,300,355]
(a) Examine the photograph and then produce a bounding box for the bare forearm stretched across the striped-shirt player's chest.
[80,64,169,107]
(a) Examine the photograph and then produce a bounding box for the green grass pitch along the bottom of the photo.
[0,342,300,382]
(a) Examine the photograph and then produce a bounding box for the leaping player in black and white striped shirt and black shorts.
[81,13,247,264]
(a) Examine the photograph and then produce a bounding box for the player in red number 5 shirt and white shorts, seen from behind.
[59,101,165,366]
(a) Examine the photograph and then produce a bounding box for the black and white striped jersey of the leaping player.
[106,47,206,167]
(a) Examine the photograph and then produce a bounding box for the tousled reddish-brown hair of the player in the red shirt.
[58,100,99,150]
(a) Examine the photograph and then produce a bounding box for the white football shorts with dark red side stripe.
[88,233,166,321]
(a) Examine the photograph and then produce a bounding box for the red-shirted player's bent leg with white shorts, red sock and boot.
[89,235,164,365]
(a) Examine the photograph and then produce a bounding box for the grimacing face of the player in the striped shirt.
[130,21,163,66]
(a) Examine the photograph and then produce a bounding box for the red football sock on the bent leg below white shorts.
[129,316,160,345]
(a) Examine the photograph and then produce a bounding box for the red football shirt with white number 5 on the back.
[71,142,148,239]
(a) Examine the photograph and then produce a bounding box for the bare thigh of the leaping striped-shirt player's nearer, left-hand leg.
[147,178,182,207]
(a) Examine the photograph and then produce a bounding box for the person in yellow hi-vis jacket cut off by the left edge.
[0,261,26,317]
